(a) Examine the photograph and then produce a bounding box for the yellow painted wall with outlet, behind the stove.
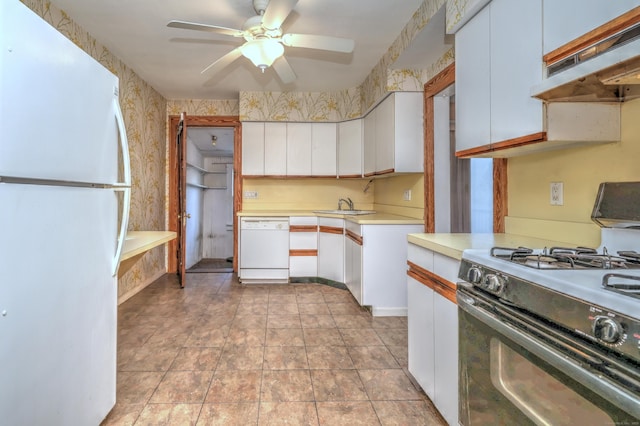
[506,99,640,245]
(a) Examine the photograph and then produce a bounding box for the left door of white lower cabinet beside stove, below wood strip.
[407,277,436,400]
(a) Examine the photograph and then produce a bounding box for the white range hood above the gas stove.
[531,24,640,102]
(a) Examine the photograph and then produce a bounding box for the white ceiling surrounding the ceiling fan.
[51,0,424,99]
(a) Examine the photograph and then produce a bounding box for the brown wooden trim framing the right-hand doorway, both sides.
[424,62,508,233]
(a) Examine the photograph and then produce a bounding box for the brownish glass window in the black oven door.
[489,337,613,426]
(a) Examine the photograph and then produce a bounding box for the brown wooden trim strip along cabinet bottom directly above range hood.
[542,6,640,66]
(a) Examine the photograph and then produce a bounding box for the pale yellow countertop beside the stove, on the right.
[407,233,575,260]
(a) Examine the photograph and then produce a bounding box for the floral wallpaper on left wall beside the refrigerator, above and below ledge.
[22,0,167,300]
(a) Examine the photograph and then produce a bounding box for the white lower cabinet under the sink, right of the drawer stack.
[318,217,345,283]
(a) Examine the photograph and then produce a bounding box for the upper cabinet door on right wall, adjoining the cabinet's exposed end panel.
[375,94,395,173]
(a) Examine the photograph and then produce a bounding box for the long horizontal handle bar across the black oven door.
[457,291,640,418]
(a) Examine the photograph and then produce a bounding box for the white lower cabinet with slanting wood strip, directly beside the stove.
[407,244,459,425]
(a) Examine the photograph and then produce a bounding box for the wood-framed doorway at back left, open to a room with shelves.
[168,114,242,286]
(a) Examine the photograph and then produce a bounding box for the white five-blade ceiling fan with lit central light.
[167,0,355,84]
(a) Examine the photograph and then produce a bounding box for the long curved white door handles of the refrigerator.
[111,95,131,277]
